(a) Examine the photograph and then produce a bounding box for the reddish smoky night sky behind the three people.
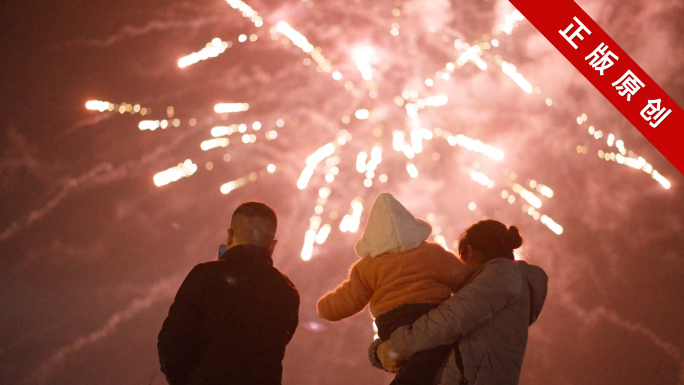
[0,0,684,385]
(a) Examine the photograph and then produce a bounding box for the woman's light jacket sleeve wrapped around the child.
[389,258,523,361]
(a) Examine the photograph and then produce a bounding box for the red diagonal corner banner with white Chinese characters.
[509,0,684,174]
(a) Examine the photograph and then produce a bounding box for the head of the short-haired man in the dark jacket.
[226,202,278,252]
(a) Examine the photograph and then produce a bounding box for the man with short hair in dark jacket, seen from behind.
[157,202,299,385]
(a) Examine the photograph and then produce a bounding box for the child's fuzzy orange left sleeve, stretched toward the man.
[316,259,373,321]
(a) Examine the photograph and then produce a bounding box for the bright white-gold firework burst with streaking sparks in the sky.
[86,0,670,260]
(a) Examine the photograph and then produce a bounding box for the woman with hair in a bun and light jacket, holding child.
[369,220,547,385]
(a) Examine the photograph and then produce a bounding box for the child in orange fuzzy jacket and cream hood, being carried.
[317,193,471,385]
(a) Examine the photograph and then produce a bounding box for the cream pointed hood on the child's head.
[355,193,432,257]
